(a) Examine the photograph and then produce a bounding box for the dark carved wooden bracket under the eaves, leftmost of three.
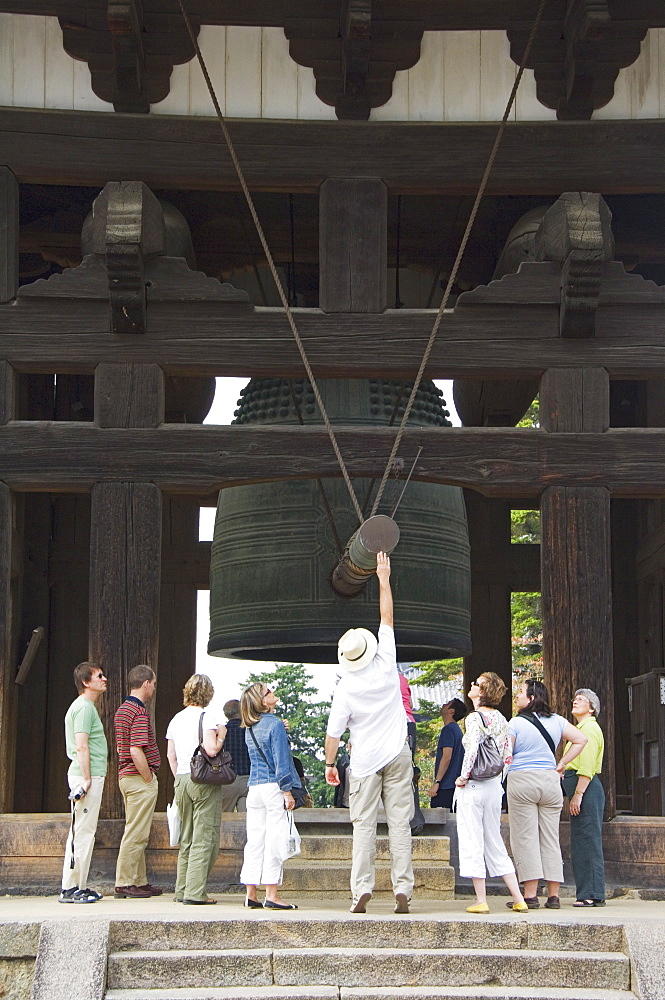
[59,0,199,113]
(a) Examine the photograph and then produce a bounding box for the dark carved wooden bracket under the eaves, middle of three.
[284,0,424,121]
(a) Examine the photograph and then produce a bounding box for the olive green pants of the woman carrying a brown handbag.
[175,774,222,900]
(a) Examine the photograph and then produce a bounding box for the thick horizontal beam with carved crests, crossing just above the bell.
[5,258,665,379]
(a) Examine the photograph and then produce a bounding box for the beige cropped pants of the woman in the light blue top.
[508,769,563,882]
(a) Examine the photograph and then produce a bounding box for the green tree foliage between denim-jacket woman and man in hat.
[247,663,334,806]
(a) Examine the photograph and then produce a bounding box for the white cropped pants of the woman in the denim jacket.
[240,781,287,885]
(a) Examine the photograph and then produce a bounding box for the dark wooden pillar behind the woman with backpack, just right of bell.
[464,490,513,718]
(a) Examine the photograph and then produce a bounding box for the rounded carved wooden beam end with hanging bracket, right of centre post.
[536,191,614,337]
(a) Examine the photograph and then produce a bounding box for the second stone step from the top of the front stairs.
[108,947,630,991]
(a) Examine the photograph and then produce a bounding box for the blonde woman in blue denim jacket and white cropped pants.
[240,682,300,910]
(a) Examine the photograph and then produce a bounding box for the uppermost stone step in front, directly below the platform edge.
[109,916,625,952]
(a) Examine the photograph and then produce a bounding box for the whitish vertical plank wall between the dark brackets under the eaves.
[0,14,665,121]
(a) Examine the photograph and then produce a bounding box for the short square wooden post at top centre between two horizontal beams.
[319,177,388,312]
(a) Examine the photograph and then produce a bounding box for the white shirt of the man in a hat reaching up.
[327,625,406,778]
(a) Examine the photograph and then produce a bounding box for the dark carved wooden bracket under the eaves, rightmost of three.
[508,0,649,120]
